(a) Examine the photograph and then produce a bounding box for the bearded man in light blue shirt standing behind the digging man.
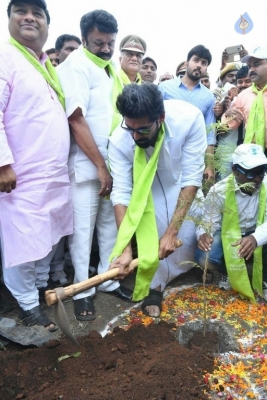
[159,45,216,180]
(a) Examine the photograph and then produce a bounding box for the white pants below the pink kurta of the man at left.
[3,245,57,311]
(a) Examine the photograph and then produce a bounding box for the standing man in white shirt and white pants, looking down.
[57,10,131,321]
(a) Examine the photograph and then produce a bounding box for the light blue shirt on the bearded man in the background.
[158,76,216,145]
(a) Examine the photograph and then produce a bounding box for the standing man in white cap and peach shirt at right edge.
[222,47,267,151]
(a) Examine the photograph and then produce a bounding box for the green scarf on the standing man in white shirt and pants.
[84,47,123,135]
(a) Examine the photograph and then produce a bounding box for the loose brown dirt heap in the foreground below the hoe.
[0,321,218,400]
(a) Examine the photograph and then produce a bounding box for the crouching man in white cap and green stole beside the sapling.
[196,143,267,301]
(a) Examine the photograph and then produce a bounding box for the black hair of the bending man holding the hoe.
[116,82,164,122]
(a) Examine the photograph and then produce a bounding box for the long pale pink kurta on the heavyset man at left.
[0,44,73,267]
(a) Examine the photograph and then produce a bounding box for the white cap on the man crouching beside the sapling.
[232,143,267,169]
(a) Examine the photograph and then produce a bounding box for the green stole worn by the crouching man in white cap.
[222,174,266,302]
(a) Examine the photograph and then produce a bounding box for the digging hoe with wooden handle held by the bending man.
[45,239,183,344]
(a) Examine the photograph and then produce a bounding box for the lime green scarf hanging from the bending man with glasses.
[109,124,165,301]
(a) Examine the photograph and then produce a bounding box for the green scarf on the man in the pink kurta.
[9,37,65,110]
